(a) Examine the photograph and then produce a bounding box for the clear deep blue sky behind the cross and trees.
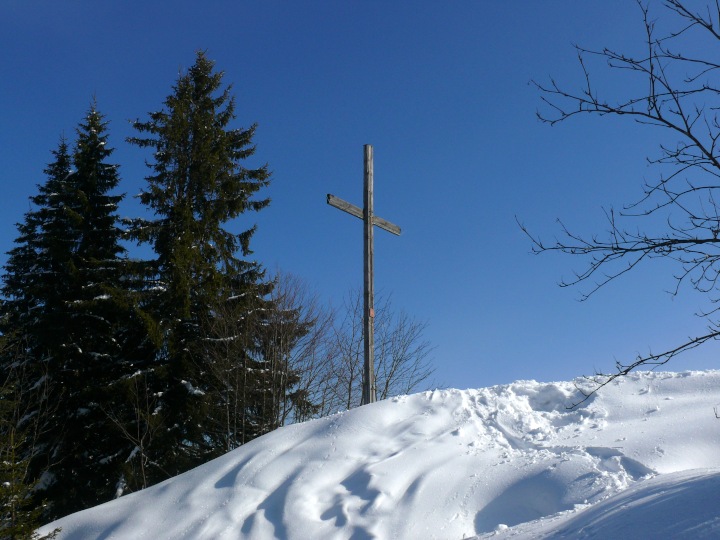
[0,0,718,388]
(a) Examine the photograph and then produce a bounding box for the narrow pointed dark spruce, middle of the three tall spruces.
[43,106,128,514]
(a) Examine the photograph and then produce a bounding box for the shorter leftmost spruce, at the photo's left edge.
[0,139,73,520]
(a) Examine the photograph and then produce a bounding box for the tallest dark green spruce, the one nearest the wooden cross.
[130,52,278,474]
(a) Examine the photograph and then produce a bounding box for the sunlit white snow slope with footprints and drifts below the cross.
[43,371,720,540]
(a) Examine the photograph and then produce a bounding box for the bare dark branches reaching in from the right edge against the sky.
[521,0,720,396]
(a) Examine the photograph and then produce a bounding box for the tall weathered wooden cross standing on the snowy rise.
[327,144,401,405]
